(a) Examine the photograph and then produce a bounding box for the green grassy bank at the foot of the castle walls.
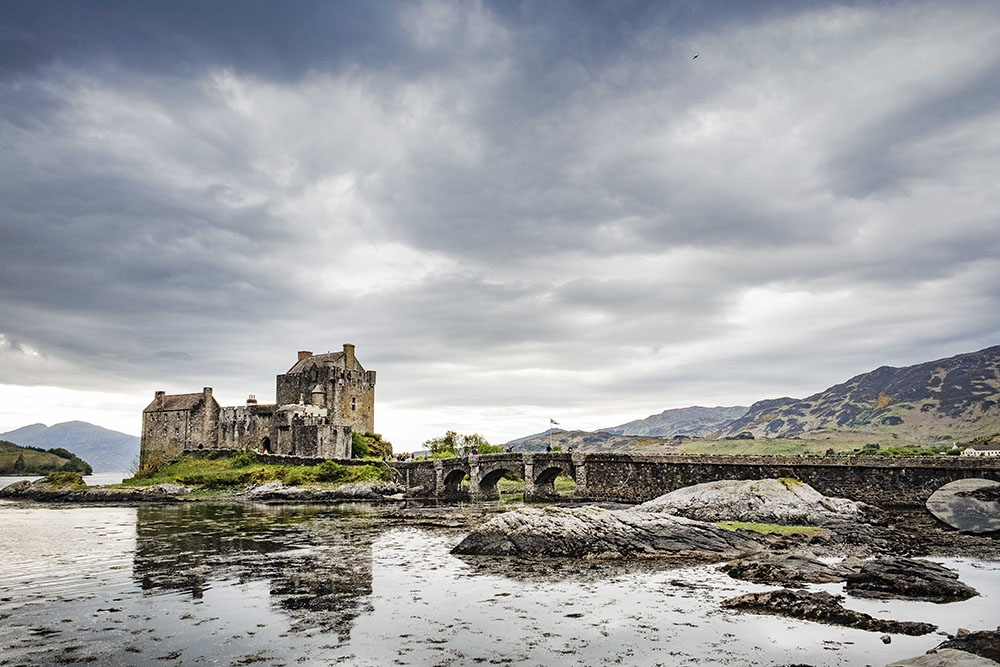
[122,452,392,491]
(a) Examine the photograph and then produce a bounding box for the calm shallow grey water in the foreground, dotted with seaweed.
[0,502,1000,665]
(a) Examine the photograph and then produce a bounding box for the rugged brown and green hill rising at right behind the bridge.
[713,346,1000,444]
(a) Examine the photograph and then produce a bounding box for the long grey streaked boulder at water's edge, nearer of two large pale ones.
[452,506,763,561]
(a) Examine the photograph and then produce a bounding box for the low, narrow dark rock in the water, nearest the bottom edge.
[722,588,937,635]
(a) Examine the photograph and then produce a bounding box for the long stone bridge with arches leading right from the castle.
[390,452,1000,506]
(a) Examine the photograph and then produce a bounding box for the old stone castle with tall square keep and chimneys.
[139,343,375,468]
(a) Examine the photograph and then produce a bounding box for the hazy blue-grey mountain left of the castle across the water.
[0,421,139,472]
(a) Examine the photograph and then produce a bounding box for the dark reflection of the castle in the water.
[133,503,379,641]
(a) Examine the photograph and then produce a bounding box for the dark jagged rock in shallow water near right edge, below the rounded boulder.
[846,557,979,602]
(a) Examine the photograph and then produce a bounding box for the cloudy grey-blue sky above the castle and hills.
[0,1,1000,450]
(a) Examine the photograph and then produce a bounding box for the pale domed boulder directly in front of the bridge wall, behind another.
[636,478,882,526]
